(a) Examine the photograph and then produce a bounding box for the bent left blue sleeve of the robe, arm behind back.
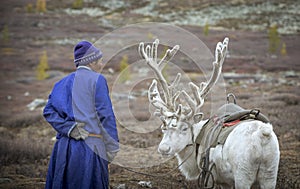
[43,95,76,137]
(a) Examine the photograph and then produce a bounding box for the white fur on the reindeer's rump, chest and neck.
[175,120,280,188]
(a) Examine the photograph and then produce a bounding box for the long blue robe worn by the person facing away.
[43,66,119,189]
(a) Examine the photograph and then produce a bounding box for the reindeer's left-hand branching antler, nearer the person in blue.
[139,39,181,116]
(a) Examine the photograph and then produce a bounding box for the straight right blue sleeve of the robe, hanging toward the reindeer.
[95,75,119,152]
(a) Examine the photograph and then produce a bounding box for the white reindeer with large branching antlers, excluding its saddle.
[138,38,280,189]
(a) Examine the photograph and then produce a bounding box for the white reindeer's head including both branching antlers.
[139,38,229,156]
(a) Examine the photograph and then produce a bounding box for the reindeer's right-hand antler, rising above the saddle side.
[182,38,229,122]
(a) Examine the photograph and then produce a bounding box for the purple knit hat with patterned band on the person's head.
[74,41,102,67]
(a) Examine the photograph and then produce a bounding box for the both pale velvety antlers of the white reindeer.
[139,38,229,122]
